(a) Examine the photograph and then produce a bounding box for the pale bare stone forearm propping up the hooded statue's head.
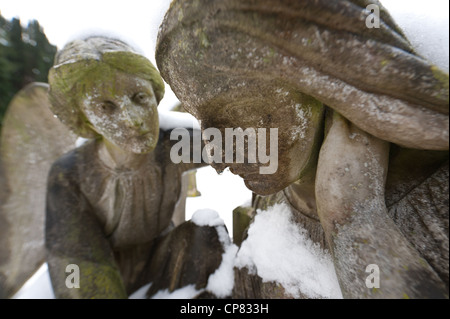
[316,113,446,298]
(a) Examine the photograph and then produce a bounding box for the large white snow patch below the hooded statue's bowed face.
[235,204,342,298]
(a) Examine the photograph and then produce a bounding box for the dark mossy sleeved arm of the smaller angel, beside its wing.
[45,153,127,298]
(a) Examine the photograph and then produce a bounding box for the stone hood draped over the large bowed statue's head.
[156,0,449,150]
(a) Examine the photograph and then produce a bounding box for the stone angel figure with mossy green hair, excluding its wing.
[0,36,223,298]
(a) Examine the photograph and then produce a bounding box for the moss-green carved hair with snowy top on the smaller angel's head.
[49,36,164,138]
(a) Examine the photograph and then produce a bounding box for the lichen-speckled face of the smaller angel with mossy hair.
[80,71,159,154]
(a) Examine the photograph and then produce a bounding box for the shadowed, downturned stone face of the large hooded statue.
[188,86,323,195]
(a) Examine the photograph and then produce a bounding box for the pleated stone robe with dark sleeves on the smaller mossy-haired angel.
[46,131,204,298]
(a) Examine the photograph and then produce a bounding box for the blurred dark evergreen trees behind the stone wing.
[0,15,56,126]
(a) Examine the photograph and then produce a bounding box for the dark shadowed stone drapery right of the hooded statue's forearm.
[386,145,449,290]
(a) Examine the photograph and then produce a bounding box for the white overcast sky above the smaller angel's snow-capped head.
[0,0,170,59]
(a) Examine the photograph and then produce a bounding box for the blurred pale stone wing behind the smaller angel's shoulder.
[0,83,76,298]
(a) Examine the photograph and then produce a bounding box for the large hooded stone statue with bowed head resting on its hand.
[156,0,449,298]
